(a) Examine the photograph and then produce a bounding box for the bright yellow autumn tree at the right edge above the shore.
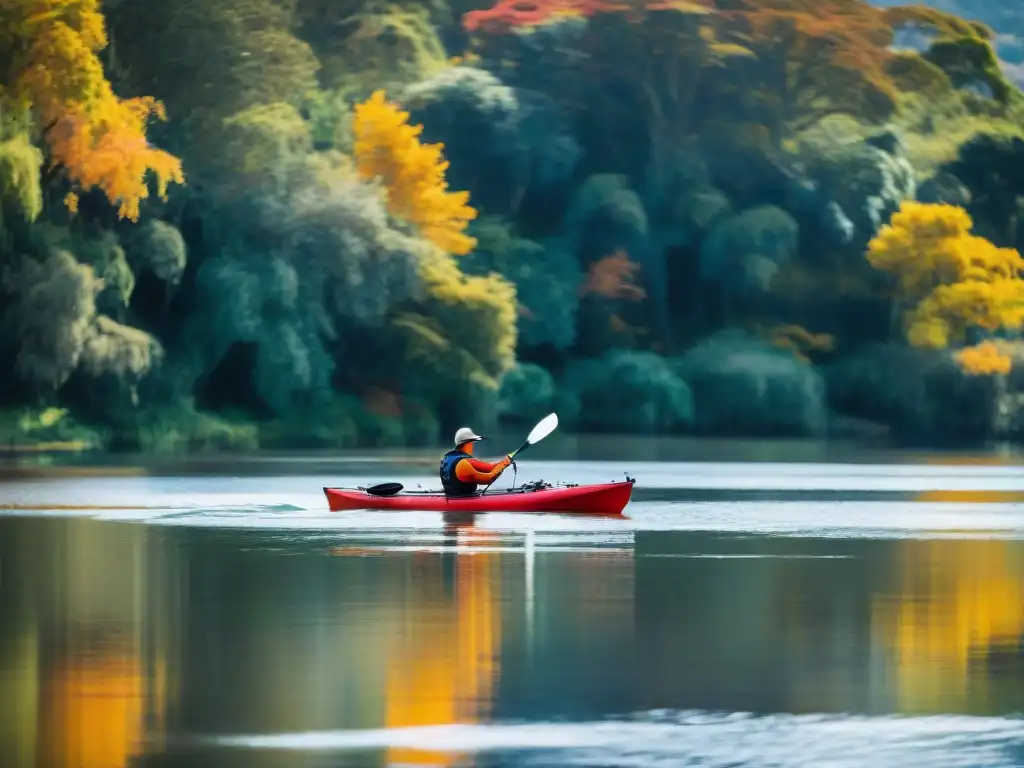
[867,202,1024,374]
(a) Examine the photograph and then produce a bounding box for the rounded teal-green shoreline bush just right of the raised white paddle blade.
[556,350,693,434]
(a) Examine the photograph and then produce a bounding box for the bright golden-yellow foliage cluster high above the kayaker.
[352,90,476,254]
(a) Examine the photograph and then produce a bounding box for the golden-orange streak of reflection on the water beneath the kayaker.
[384,528,502,766]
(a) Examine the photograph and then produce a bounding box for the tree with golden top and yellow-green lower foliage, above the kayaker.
[352,90,517,415]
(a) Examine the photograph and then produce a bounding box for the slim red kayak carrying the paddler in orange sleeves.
[324,478,636,515]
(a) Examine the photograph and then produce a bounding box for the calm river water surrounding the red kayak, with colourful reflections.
[0,446,1024,768]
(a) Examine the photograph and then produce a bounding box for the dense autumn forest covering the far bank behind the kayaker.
[0,0,1024,452]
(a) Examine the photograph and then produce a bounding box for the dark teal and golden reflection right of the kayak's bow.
[636,534,1024,714]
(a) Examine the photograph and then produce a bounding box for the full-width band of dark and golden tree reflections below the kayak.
[9,519,1024,768]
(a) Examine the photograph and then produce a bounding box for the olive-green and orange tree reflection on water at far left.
[0,520,166,768]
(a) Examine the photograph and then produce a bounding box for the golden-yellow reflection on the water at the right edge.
[871,540,1024,713]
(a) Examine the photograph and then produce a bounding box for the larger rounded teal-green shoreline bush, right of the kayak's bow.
[674,332,826,436]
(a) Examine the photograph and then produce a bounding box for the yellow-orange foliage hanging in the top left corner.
[0,0,184,220]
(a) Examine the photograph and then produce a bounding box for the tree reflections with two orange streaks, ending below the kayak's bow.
[0,519,634,768]
